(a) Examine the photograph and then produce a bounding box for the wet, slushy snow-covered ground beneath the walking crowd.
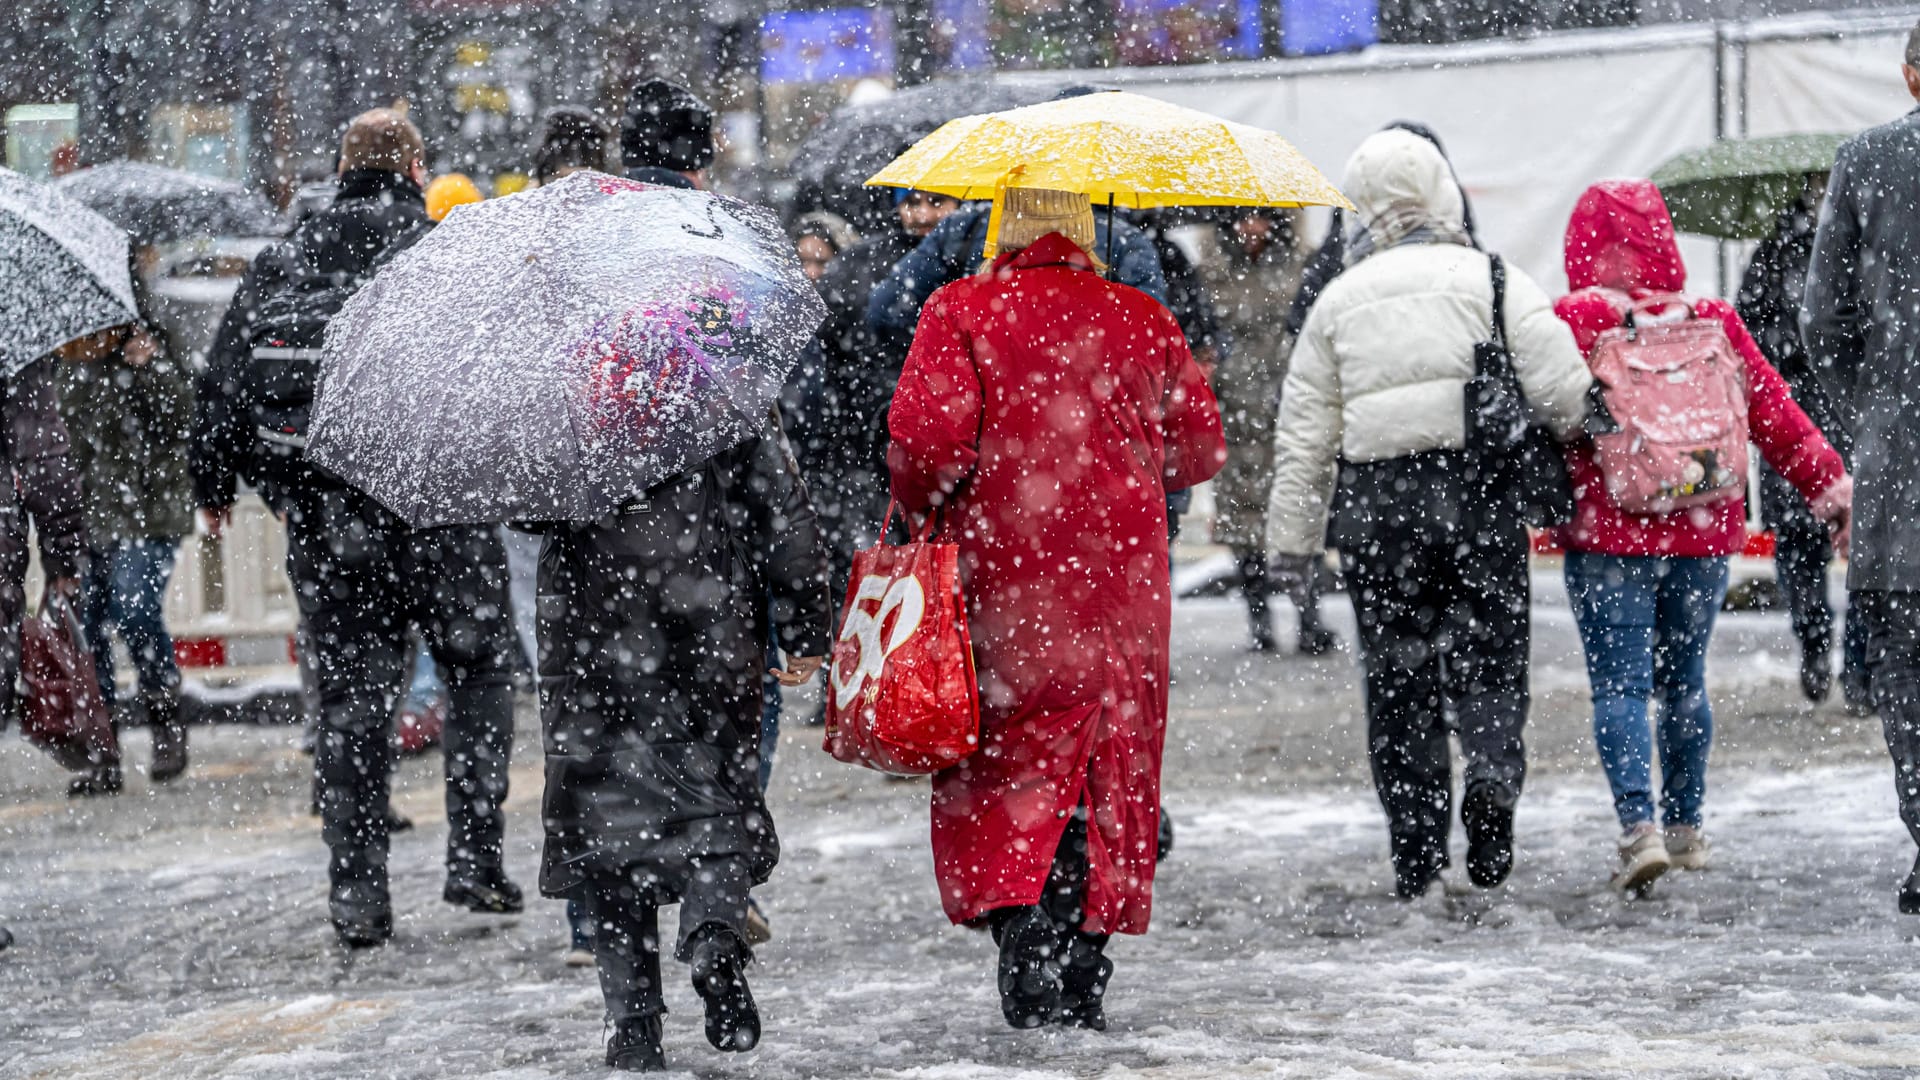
[0,575,1920,1080]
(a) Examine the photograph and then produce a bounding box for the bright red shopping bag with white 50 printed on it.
[826,505,979,774]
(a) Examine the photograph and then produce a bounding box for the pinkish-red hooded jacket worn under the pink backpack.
[1553,181,1847,555]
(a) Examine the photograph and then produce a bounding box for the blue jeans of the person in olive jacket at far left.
[81,540,180,705]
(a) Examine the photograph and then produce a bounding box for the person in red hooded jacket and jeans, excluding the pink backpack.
[1555,181,1853,892]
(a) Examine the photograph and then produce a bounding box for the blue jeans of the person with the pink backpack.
[1567,552,1726,828]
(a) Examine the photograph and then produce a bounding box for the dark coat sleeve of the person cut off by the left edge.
[4,359,86,578]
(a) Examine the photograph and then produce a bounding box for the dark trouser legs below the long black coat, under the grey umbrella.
[582,855,753,1022]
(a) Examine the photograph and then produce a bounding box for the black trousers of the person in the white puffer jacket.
[1340,525,1530,876]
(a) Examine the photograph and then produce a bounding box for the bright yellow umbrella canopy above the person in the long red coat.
[868,90,1354,209]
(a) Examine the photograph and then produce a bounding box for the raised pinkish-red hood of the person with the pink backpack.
[1567,181,1686,292]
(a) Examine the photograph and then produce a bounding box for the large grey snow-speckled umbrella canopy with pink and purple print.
[307,173,826,527]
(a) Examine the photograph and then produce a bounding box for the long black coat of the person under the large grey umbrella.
[540,421,829,903]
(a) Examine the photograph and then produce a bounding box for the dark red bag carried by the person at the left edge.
[19,592,119,771]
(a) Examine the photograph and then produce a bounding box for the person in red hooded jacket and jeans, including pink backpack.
[1553,181,1853,892]
